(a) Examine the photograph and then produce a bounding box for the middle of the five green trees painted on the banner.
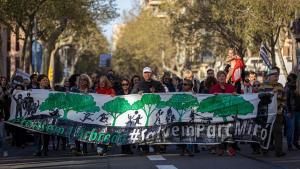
[131,94,166,126]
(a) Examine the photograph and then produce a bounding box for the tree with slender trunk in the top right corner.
[240,0,300,66]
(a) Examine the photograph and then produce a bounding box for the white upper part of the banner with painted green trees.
[10,90,277,127]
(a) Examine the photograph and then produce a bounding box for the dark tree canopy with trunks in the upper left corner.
[0,0,117,72]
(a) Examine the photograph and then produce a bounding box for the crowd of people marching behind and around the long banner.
[0,49,300,157]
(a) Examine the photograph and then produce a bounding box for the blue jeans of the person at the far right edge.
[285,113,295,146]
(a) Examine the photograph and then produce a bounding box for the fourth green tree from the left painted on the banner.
[167,94,198,122]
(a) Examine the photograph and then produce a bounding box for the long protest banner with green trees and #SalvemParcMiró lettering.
[7,90,277,148]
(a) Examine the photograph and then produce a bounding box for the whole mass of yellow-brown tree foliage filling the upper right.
[170,0,300,65]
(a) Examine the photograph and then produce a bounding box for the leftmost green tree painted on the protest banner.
[39,93,100,119]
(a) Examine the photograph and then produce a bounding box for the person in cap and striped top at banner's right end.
[259,67,286,157]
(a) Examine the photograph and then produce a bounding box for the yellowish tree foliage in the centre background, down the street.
[113,11,175,75]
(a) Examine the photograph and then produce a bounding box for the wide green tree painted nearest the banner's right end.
[197,94,254,122]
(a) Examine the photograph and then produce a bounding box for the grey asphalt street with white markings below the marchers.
[0,144,300,169]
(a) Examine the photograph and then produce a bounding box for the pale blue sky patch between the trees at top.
[103,0,134,42]
